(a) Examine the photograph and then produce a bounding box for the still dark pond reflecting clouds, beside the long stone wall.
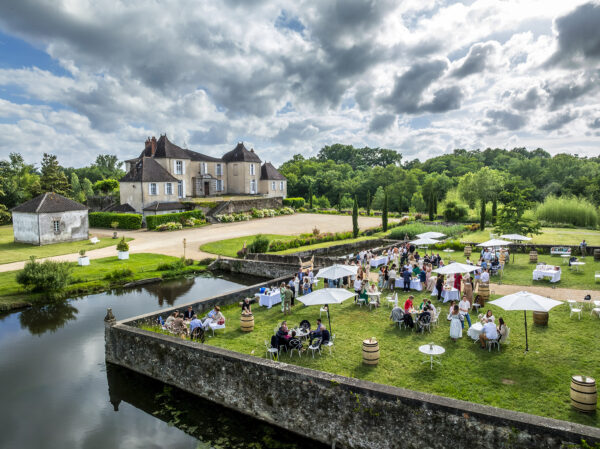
[0,276,321,449]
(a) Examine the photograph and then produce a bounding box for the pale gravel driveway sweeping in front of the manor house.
[0,214,381,272]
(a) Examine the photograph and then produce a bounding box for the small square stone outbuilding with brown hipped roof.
[11,192,89,245]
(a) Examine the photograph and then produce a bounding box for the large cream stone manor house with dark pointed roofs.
[118,135,287,215]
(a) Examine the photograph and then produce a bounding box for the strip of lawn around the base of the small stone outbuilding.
[0,226,131,264]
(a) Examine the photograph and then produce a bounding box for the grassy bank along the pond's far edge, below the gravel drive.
[0,254,206,310]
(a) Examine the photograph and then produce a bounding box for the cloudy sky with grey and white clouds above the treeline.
[0,0,600,166]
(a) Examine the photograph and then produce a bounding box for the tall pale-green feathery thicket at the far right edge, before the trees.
[535,195,598,228]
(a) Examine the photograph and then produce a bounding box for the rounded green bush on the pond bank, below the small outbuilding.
[17,256,72,297]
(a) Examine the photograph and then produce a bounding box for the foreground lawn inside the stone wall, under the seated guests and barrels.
[143,288,600,426]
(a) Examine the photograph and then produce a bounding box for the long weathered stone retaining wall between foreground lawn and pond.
[105,317,600,449]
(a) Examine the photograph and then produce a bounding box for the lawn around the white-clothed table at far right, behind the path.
[448,251,600,288]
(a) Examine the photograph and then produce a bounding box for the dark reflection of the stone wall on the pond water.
[106,363,328,449]
